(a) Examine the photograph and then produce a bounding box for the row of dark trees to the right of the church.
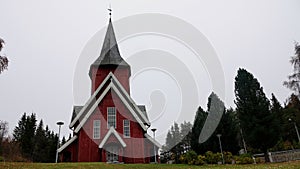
[161,43,300,163]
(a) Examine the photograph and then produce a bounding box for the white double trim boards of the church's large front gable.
[70,73,150,133]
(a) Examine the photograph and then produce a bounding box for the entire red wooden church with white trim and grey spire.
[58,16,160,163]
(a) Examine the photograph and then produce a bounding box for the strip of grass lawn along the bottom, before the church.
[0,161,300,169]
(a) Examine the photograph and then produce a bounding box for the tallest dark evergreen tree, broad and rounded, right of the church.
[235,69,279,161]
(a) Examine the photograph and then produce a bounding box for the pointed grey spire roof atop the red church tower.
[92,18,129,66]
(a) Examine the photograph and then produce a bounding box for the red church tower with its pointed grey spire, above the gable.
[89,18,131,95]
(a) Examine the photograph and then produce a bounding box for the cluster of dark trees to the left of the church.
[0,113,58,162]
